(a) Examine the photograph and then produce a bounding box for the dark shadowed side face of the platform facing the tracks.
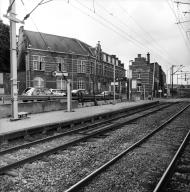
[0,102,160,145]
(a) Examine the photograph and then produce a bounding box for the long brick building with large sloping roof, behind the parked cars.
[18,27,125,93]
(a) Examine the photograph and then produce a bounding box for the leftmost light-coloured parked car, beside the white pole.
[22,87,52,96]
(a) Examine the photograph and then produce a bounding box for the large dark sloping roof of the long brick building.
[23,30,94,56]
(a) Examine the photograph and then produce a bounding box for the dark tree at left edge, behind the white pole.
[0,21,10,72]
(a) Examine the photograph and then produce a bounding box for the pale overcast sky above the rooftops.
[0,0,190,84]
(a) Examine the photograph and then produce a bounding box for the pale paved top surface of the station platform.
[0,100,152,135]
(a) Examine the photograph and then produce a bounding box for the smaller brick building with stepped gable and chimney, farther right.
[129,53,166,98]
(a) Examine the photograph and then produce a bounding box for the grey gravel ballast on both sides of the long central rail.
[0,102,189,192]
